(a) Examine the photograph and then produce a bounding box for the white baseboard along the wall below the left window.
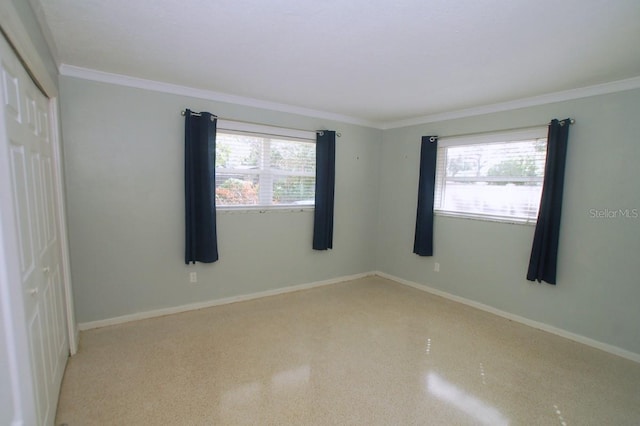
[78,272,374,331]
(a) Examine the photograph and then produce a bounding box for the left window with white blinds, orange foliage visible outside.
[216,120,316,208]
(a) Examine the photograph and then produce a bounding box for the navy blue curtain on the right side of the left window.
[313,130,336,250]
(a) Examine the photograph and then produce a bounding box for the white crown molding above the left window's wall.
[59,64,382,129]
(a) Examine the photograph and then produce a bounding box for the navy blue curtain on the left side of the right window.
[413,136,438,256]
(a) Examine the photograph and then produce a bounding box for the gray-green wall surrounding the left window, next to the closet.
[60,77,382,323]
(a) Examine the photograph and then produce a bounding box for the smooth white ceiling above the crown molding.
[31,0,640,124]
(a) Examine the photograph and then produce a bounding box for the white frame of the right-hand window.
[433,126,548,226]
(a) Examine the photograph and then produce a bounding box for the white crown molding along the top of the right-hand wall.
[381,76,640,130]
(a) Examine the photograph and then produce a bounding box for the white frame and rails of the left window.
[216,119,316,213]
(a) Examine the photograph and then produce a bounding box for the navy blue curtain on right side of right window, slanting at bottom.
[527,118,571,284]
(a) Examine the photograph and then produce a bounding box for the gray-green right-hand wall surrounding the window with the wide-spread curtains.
[376,90,640,354]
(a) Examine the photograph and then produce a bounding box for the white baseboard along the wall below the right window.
[374,271,640,363]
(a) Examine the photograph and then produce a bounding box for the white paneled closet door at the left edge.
[0,37,69,425]
